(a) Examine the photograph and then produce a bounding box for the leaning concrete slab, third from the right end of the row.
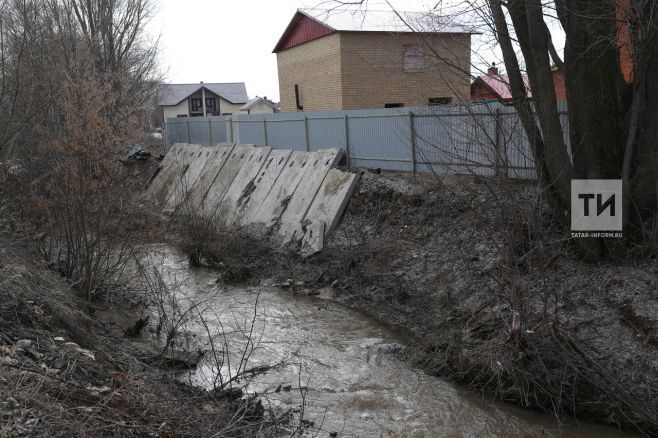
[254,151,318,227]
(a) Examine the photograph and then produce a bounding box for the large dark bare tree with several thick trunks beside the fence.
[321,0,658,260]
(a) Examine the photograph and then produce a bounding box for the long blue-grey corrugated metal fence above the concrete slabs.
[165,103,569,178]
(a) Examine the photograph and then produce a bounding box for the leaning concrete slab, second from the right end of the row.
[281,149,342,228]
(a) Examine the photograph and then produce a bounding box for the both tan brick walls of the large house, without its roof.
[277,32,471,111]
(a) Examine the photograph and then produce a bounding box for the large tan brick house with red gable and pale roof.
[273,9,471,111]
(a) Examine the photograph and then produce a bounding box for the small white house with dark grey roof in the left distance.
[158,82,249,120]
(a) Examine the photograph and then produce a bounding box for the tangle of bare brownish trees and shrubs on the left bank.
[0,0,158,299]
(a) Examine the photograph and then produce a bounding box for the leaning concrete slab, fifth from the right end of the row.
[216,146,272,225]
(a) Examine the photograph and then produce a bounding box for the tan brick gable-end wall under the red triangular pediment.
[277,33,342,112]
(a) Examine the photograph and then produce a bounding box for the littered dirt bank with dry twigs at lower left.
[0,230,264,437]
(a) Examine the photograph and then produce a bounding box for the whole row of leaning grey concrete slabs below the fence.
[146,143,358,254]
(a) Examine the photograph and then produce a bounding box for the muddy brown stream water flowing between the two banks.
[155,251,636,437]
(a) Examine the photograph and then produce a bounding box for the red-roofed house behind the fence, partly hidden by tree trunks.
[471,65,567,104]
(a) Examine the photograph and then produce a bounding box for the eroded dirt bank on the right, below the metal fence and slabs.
[183,169,658,435]
